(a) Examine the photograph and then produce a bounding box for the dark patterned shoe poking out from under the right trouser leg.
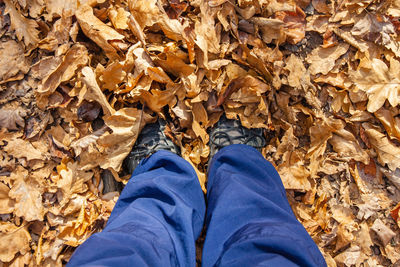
[210,115,267,159]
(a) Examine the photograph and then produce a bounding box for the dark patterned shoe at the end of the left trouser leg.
[122,119,180,174]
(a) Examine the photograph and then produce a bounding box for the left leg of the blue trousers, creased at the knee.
[68,151,205,267]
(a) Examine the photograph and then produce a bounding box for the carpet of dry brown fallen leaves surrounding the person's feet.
[0,0,400,266]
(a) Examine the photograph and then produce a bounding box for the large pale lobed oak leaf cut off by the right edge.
[351,58,400,112]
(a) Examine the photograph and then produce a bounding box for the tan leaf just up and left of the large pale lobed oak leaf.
[306,43,350,75]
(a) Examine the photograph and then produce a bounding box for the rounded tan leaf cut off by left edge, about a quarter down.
[0,40,29,84]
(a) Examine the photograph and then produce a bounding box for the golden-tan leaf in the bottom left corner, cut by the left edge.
[0,223,31,262]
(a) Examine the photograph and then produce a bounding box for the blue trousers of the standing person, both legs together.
[68,145,326,267]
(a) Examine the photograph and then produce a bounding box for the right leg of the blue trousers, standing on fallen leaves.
[202,145,326,267]
